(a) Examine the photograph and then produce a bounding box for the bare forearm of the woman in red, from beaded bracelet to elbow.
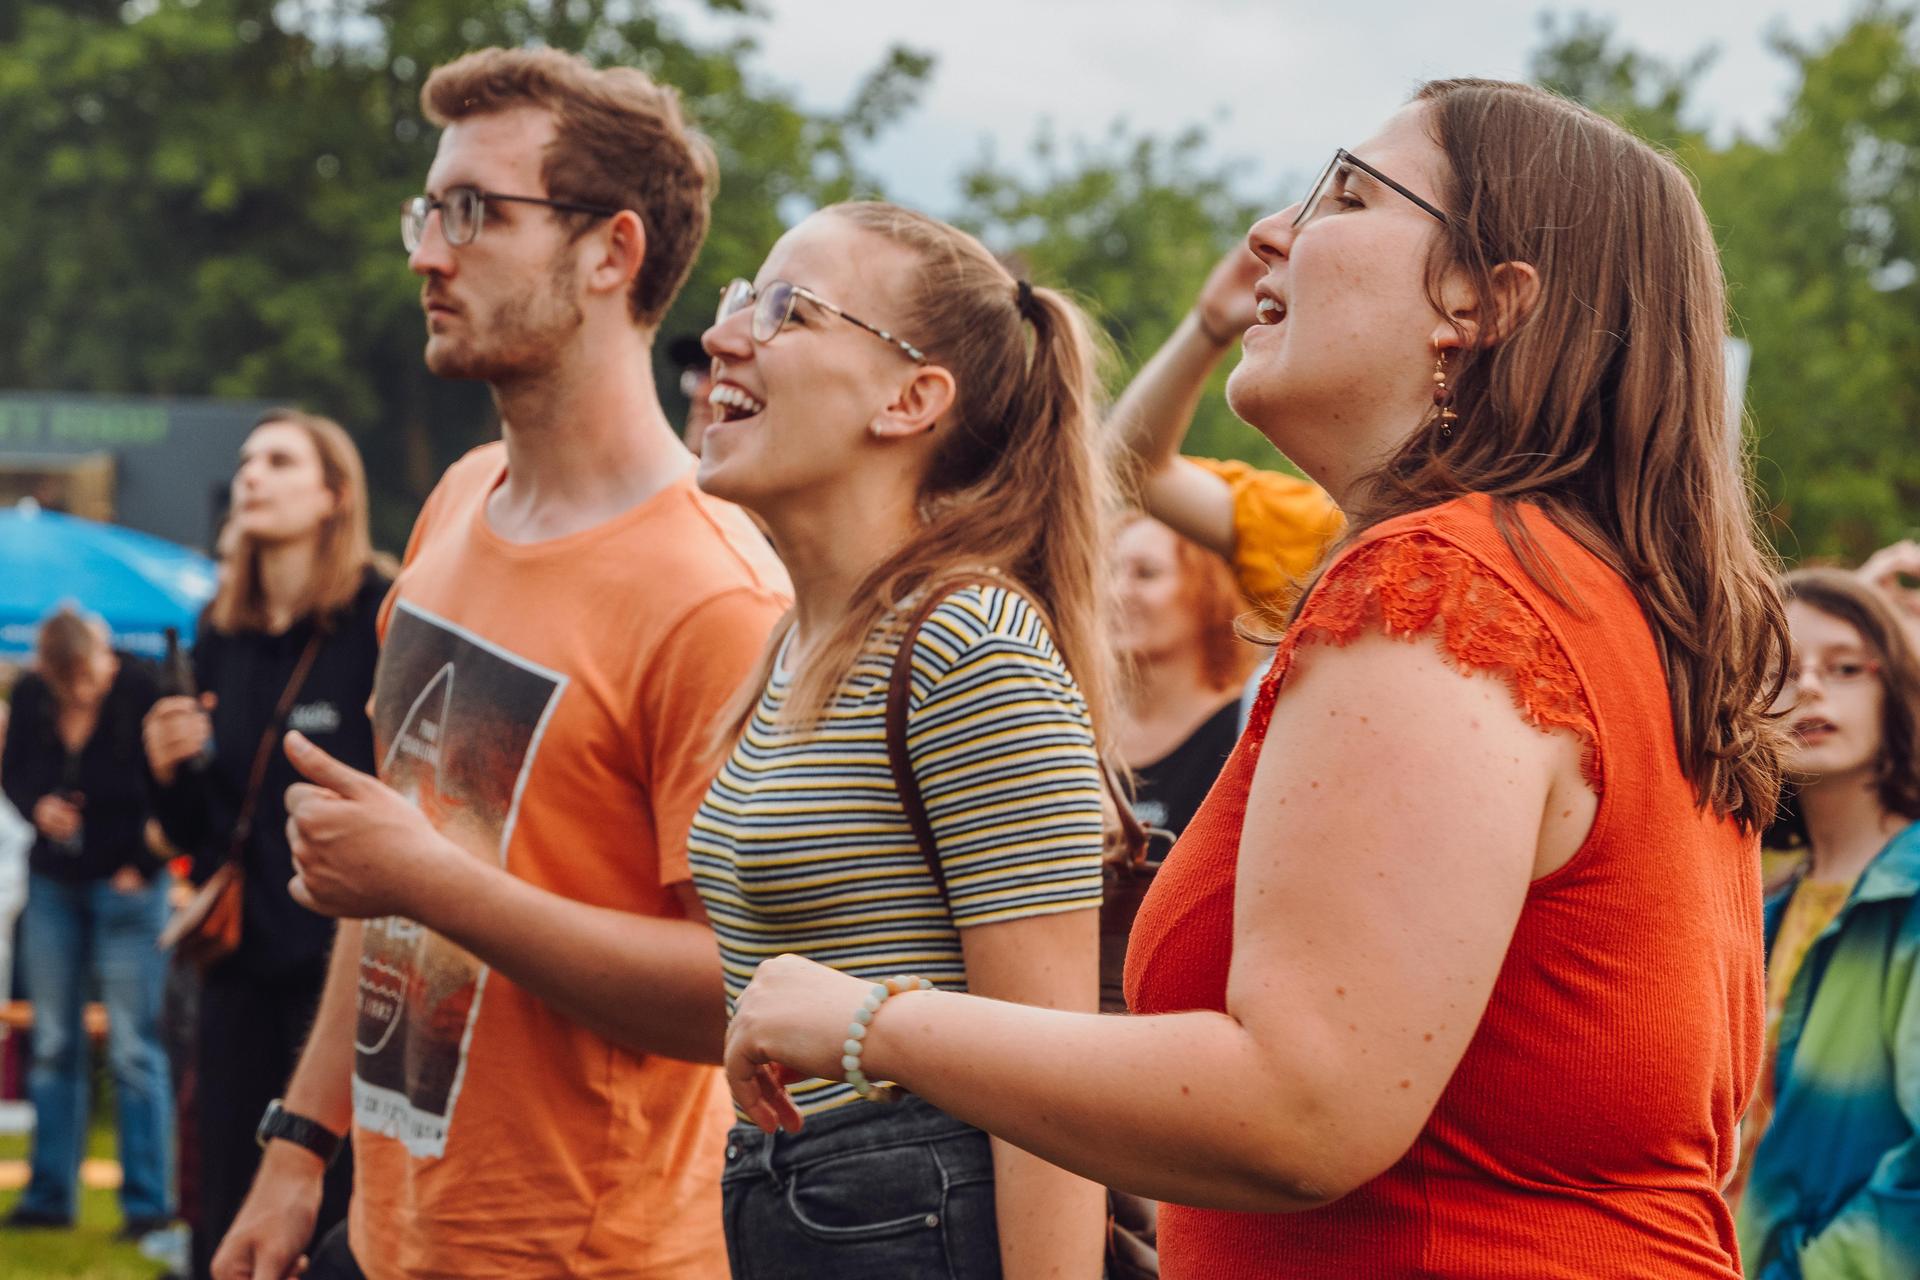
[864,992,1346,1213]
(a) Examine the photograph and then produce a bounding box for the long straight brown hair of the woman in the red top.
[1296,81,1788,831]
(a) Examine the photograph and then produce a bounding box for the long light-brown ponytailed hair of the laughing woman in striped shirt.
[724,201,1114,745]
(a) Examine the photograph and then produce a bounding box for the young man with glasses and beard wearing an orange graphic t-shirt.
[215,50,787,1280]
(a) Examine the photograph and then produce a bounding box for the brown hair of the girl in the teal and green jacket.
[1780,568,1920,819]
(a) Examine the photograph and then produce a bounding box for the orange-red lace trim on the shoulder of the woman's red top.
[1248,533,1599,793]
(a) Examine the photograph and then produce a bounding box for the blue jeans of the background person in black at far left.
[19,873,173,1219]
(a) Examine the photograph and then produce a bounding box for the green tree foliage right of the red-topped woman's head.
[1534,2,1920,562]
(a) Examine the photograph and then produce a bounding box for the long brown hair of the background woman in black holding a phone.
[207,409,372,633]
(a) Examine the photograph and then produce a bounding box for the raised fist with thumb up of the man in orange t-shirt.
[286,733,467,919]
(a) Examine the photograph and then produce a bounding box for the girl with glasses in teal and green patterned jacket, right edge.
[1728,570,1920,1280]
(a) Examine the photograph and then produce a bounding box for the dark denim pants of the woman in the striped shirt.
[720,1098,1000,1280]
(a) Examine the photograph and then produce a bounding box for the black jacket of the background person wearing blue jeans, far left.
[0,654,159,881]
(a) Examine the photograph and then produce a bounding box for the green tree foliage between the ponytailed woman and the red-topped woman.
[956,125,1286,466]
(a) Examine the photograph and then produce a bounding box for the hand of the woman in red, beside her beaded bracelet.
[726,956,872,1132]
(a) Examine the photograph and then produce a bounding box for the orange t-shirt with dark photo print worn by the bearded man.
[351,443,787,1280]
